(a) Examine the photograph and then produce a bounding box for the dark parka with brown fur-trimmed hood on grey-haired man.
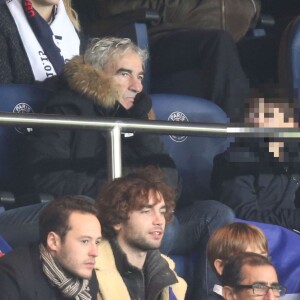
[28,56,178,197]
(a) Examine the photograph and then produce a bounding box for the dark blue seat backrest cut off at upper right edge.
[278,16,300,105]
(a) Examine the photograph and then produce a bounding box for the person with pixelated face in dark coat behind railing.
[212,98,300,231]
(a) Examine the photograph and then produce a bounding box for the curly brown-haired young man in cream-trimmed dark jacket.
[96,167,186,300]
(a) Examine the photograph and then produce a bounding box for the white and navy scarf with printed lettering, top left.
[7,0,80,81]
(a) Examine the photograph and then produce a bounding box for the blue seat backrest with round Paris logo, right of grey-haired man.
[151,94,229,200]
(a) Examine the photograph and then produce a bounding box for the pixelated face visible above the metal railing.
[245,98,295,128]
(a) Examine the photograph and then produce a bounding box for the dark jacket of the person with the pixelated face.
[212,140,300,230]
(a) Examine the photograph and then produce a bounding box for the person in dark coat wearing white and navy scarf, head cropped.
[0,0,83,84]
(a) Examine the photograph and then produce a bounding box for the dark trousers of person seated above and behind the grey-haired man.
[150,30,250,120]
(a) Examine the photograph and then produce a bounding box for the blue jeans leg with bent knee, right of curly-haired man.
[160,200,234,300]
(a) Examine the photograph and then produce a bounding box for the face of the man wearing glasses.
[227,265,278,300]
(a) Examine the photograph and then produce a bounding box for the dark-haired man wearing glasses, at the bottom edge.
[221,252,286,300]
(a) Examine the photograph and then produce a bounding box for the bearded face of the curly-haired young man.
[115,192,166,253]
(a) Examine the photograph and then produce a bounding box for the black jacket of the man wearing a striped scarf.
[0,244,99,300]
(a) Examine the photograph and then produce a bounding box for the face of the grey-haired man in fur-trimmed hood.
[105,52,144,110]
